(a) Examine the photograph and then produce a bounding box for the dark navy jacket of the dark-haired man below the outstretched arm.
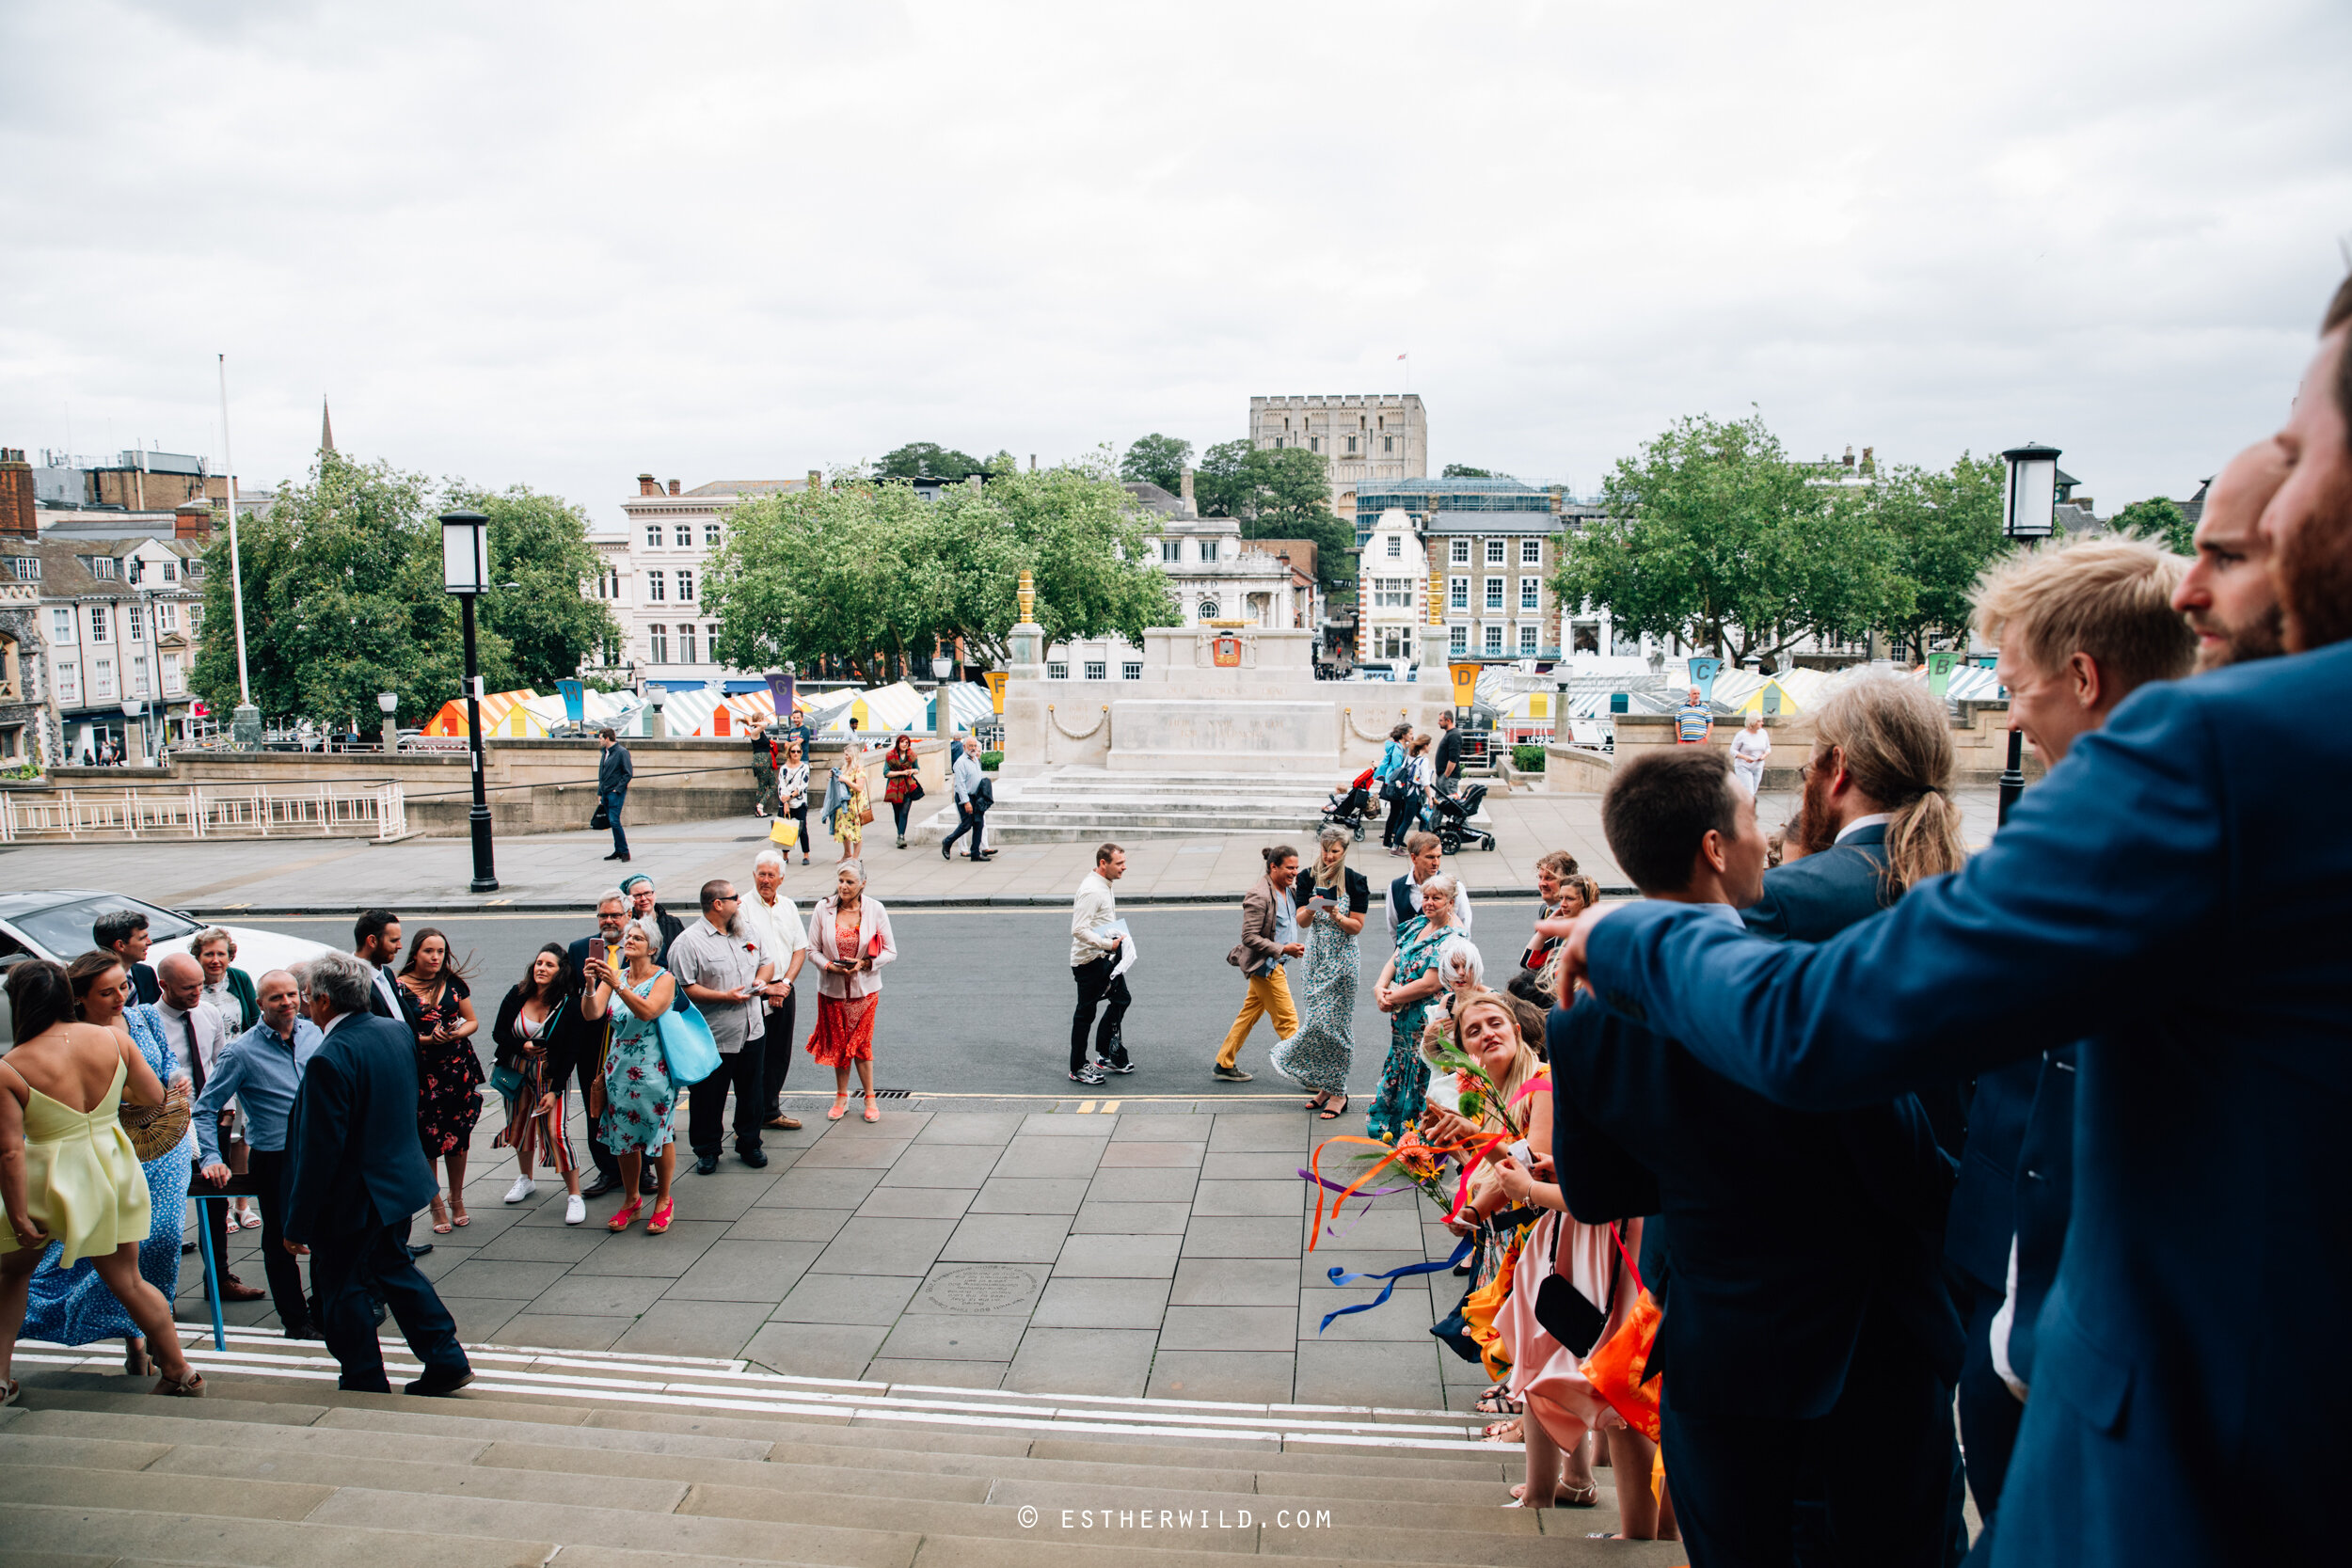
[1546,982,1962,1420]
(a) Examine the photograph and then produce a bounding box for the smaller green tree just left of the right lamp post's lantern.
[1863,451,2009,660]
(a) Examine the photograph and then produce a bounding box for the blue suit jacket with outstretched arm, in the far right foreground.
[1590,644,2352,1568]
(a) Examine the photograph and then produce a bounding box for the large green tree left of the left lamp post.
[196,451,496,726]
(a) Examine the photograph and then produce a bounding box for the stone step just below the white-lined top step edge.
[0,1373,1522,1486]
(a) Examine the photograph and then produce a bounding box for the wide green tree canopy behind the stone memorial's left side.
[704,463,1176,677]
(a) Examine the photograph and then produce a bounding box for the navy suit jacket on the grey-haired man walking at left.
[285,1013,437,1243]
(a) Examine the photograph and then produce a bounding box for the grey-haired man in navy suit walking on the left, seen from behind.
[285,952,473,1394]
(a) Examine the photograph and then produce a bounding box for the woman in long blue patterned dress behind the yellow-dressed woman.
[22,952,188,1378]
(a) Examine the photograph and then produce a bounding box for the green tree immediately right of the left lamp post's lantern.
[445,484,621,691]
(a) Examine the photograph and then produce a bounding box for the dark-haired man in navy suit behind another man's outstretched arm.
[1548,748,1962,1568]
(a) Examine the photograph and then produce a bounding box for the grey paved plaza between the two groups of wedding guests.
[179,1101,1486,1408]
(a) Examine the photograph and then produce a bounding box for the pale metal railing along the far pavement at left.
[0,781,409,844]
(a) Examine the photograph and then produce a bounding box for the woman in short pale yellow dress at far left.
[0,959,205,1403]
